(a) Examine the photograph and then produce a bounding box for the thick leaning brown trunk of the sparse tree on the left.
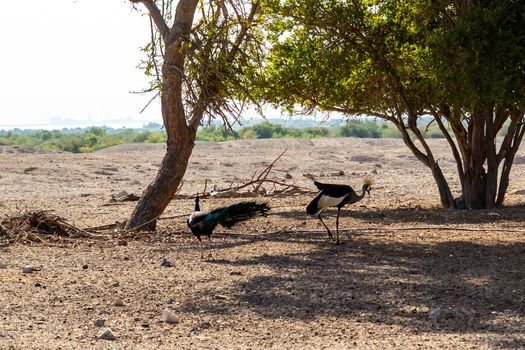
[126,0,202,231]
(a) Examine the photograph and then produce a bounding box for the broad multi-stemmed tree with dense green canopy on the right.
[257,0,525,208]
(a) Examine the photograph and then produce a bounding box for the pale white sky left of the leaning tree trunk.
[0,0,161,129]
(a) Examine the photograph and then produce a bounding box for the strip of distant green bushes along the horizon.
[0,120,466,153]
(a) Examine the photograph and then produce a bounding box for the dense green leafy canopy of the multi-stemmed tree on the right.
[253,0,525,128]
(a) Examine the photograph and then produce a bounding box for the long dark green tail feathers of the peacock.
[206,202,270,228]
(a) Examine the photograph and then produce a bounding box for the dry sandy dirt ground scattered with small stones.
[0,139,525,349]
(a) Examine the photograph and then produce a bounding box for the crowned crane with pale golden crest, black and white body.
[306,179,373,244]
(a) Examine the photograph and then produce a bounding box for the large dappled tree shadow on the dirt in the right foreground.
[182,235,525,347]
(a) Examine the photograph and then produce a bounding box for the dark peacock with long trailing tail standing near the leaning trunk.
[187,196,270,259]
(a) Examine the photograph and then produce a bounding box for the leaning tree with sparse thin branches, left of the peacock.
[126,0,260,230]
